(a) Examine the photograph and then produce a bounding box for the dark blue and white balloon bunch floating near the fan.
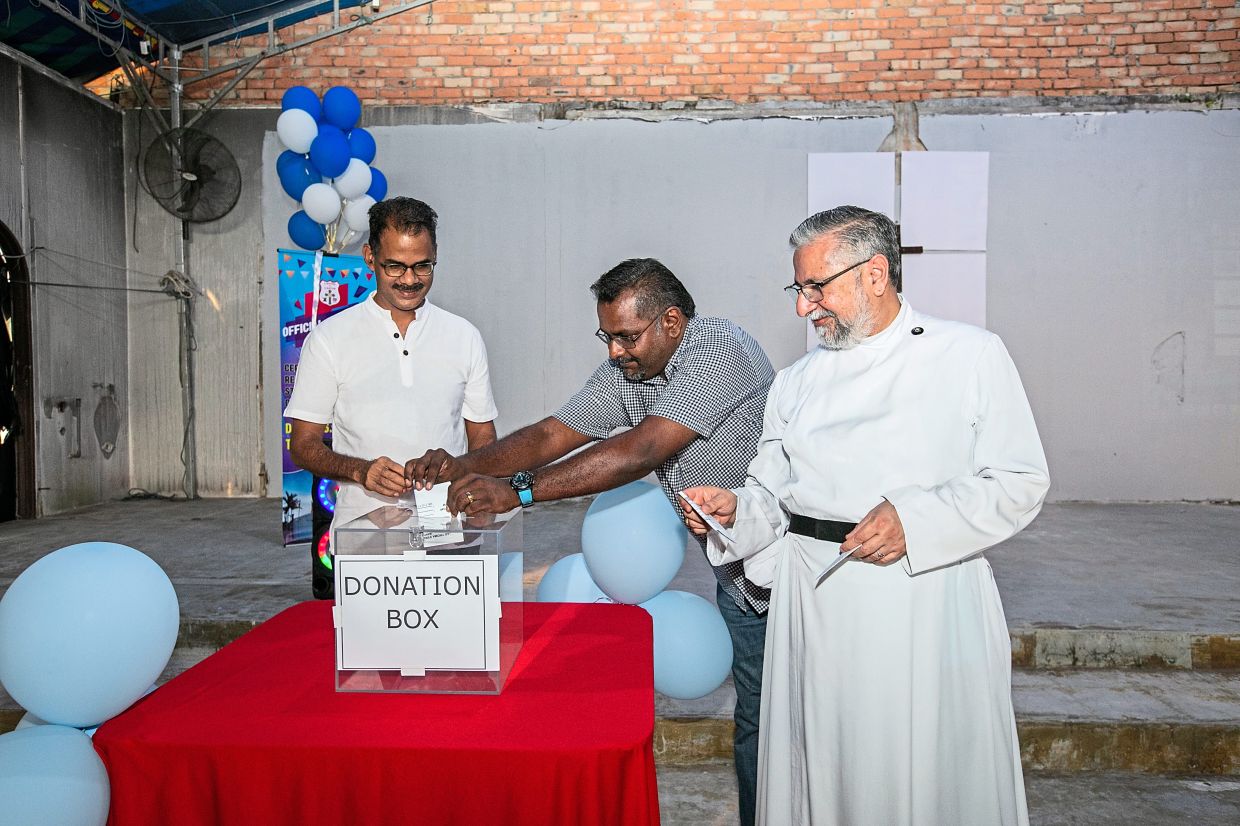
[275,86,387,253]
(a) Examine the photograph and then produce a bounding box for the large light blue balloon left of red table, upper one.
[0,542,180,728]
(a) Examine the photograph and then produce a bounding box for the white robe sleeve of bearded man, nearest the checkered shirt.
[706,373,790,588]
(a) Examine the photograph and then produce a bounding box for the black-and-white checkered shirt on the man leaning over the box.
[554,316,775,613]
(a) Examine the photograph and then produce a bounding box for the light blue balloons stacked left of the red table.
[0,542,180,826]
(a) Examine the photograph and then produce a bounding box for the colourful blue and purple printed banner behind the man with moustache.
[275,249,374,544]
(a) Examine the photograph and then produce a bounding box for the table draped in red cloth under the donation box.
[94,603,658,826]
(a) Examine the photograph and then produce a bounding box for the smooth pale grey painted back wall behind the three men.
[256,110,1240,501]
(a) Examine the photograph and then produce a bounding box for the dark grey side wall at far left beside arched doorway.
[0,53,129,513]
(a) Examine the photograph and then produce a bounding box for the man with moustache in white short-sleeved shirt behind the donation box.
[284,197,497,530]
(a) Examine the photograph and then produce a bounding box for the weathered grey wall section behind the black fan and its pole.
[125,109,271,496]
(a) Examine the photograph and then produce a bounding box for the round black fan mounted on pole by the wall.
[141,127,241,223]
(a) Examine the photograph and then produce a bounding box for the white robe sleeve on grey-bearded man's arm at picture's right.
[884,336,1050,574]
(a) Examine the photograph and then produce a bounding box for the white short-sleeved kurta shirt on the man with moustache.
[284,294,498,530]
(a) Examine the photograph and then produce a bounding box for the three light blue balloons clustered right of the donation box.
[538,481,733,699]
